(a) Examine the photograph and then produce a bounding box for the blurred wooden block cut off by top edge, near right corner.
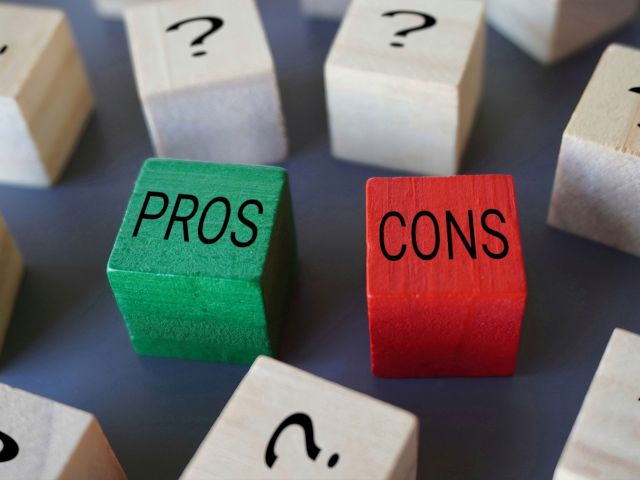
[487,0,638,64]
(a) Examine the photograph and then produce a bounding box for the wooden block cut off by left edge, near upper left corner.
[0,4,93,187]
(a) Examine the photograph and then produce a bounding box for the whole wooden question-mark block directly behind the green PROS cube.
[125,0,287,163]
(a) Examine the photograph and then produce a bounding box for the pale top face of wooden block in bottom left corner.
[0,384,94,478]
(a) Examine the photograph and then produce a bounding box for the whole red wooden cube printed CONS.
[367,175,527,377]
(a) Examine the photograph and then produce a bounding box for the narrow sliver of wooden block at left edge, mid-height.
[0,216,24,351]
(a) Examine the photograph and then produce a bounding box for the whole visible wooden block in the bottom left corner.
[0,384,126,480]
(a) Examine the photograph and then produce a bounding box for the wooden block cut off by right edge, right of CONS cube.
[548,45,640,255]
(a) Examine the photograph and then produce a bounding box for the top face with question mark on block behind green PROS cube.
[125,0,274,98]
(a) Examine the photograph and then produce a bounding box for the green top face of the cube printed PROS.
[108,159,288,282]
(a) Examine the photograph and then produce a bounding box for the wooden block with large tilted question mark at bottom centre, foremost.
[181,357,418,480]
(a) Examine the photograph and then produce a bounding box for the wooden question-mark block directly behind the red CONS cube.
[325,0,485,175]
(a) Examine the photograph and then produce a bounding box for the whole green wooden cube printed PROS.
[107,159,296,364]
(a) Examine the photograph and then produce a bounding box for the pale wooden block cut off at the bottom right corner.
[553,329,640,480]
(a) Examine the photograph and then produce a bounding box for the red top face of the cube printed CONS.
[367,175,526,299]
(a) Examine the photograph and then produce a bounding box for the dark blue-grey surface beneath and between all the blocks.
[0,0,640,480]
